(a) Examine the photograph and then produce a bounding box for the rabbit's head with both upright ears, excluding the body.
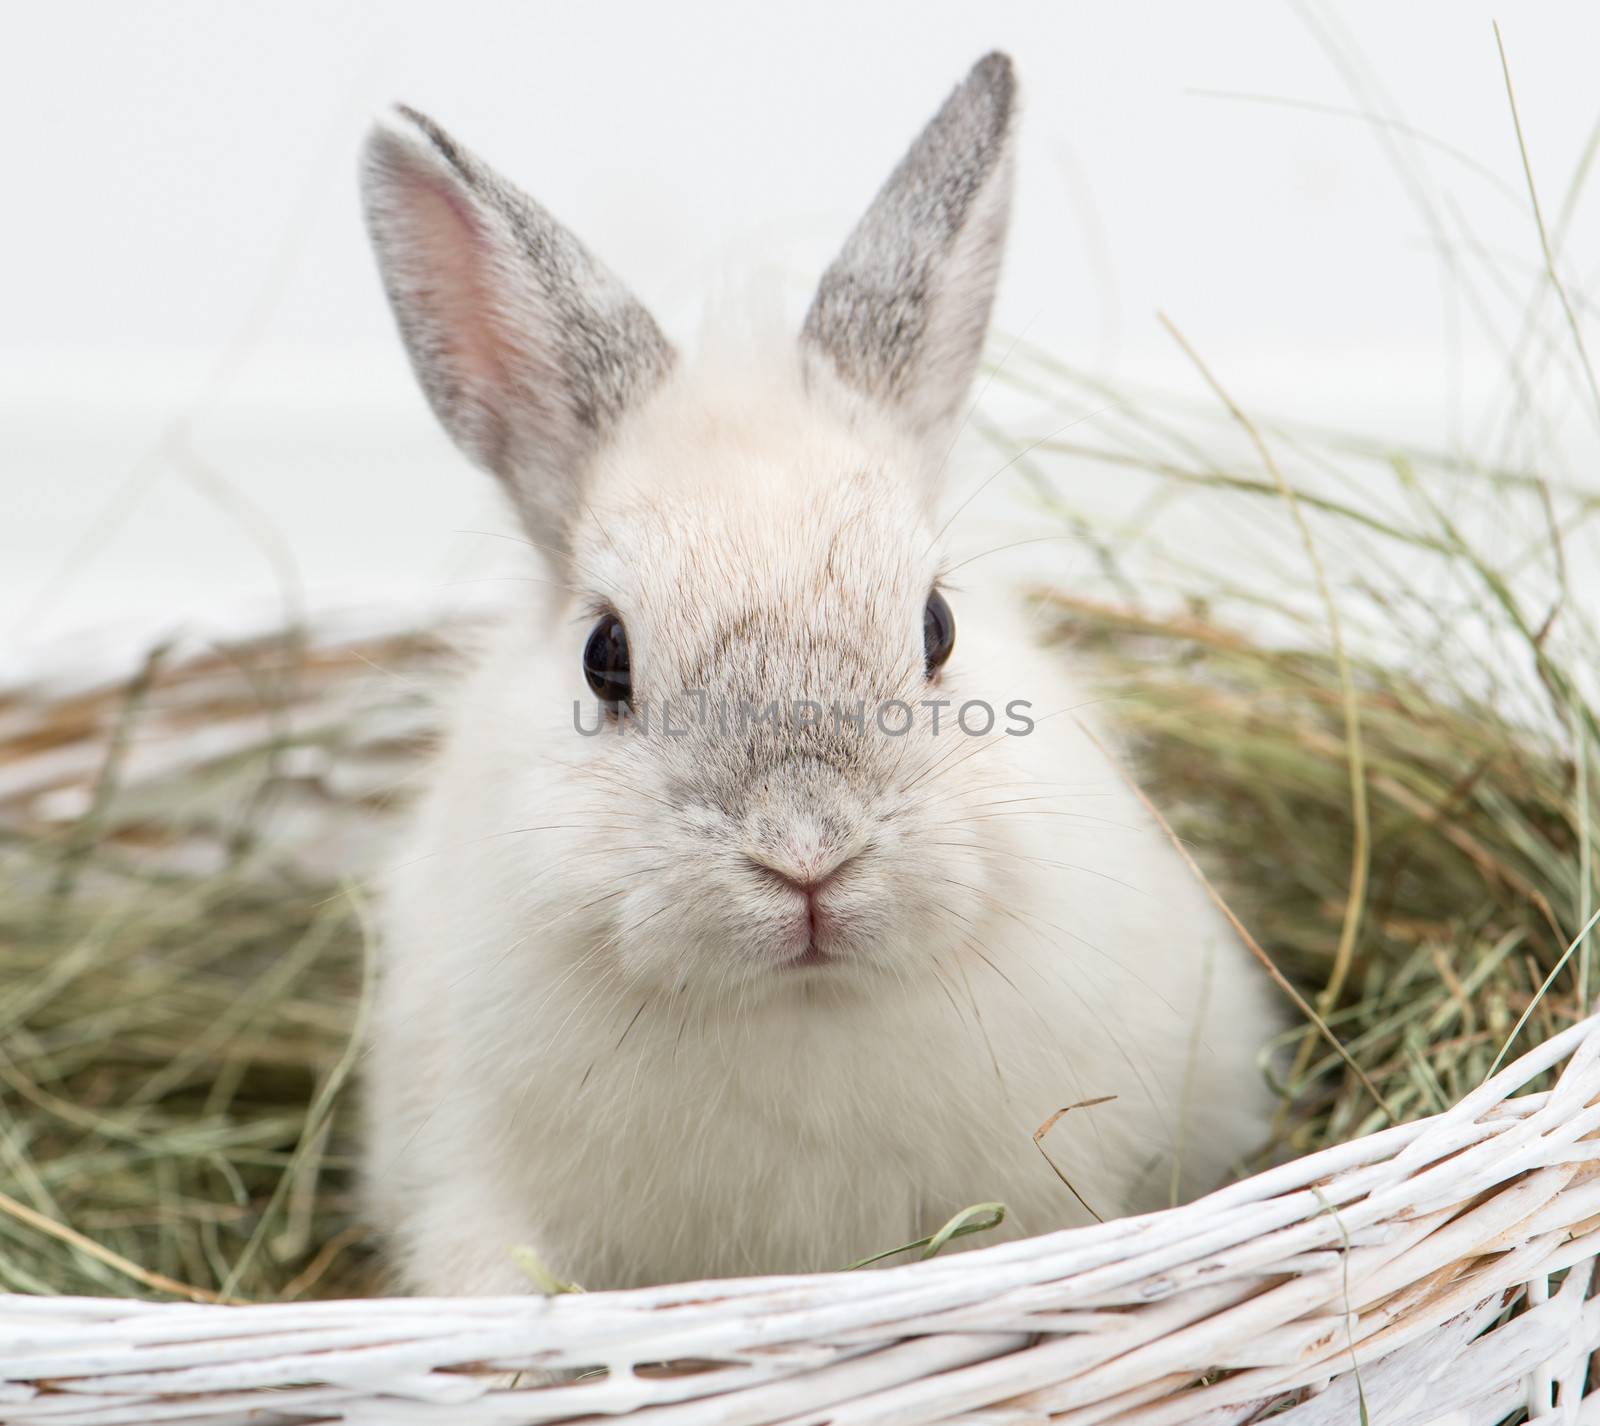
[365,54,1014,995]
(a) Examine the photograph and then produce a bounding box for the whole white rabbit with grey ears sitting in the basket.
[363,54,1275,1295]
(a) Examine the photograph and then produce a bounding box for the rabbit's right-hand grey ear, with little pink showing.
[802,54,1016,467]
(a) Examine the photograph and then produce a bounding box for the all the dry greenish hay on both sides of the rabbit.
[0,347,1600,1301]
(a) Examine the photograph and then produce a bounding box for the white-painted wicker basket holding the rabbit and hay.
[0,627,1600,1426]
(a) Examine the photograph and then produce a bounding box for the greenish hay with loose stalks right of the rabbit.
[985,334,1600,1157]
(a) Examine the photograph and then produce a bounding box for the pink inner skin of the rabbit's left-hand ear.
[406,174,509,422]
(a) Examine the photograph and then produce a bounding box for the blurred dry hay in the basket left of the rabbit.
[0,637,438,1300]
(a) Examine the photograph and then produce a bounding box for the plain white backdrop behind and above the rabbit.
[0,0,1600,671]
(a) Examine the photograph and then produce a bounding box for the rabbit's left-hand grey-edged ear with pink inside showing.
[362,107,674,547]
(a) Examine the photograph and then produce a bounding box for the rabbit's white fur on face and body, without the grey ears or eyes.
[365,62,1272,1293]
